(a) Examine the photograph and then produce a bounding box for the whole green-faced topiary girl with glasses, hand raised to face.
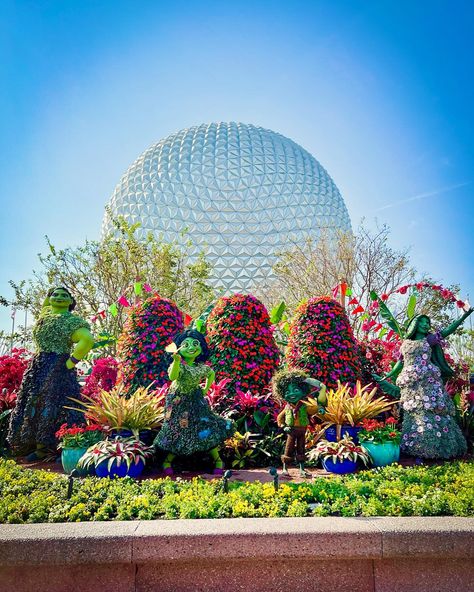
[154,330,235,475]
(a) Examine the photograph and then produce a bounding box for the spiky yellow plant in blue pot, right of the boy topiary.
[308,381,396,443]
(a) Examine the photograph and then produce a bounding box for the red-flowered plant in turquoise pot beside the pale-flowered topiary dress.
[359,417,401,467]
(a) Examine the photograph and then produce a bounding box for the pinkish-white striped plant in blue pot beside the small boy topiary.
[308,434,370,474]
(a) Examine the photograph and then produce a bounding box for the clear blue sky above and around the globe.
[0,0,474,328]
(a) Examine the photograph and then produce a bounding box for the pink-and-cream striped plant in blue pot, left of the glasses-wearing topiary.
[78,437,153,477]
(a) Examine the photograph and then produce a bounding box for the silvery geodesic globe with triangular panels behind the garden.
[102,122,351,293]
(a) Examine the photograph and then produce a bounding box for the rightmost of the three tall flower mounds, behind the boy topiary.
[287,297,361,388]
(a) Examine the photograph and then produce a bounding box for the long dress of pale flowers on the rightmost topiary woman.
[397,334,467,458]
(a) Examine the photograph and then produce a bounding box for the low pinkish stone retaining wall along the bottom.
[0,517,474,592]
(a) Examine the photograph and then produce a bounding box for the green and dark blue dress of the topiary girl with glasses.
[154,361,235,456]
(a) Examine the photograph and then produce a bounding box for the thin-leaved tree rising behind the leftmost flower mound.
[0,217,213,355]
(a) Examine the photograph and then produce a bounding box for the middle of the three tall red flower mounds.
[207,294,280,395]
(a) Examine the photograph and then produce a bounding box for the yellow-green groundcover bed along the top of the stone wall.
[0,459,474,523]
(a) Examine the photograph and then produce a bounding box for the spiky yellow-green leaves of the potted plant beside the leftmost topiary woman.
[67,384,165,436]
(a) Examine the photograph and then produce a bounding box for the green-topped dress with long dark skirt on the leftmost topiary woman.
[8,310,90,451]
